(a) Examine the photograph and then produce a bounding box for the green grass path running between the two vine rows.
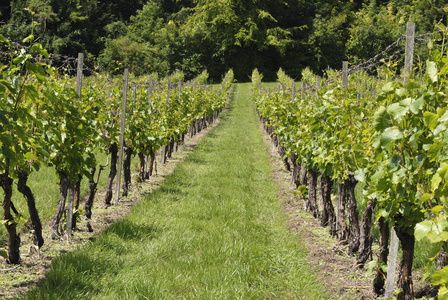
[28,84,328,299]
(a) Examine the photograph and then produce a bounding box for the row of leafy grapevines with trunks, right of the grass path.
[253,25,448,299]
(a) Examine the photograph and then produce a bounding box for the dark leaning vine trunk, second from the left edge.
[17,171,44,248]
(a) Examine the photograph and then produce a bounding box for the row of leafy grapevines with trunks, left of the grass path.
[0,35,233,264]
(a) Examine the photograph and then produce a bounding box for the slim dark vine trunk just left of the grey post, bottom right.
[373,217,390,296]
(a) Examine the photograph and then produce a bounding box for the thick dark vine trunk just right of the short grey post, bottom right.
[395,226,415,300]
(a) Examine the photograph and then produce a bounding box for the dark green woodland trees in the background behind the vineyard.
[0,0,448,81]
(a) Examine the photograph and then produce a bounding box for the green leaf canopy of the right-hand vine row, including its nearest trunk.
[253,25,448,299]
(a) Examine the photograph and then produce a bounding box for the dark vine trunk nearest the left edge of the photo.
[0,158,20,264]
